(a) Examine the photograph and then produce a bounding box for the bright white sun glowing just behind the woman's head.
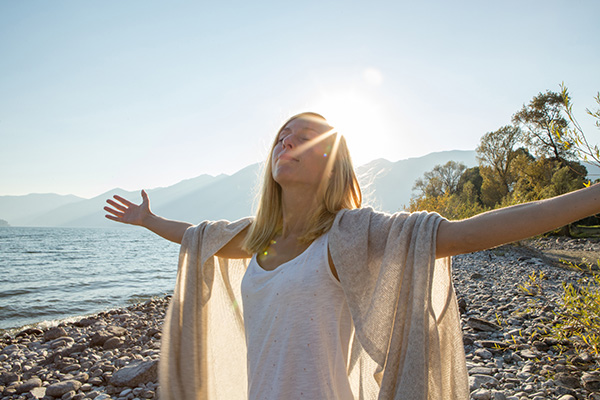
[311,90,389,166]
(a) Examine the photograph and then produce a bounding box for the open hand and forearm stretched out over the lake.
[104,190,192,243]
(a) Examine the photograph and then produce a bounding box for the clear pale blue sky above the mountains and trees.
[0,0,600,197]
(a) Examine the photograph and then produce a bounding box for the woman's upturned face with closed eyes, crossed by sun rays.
[271,118,333,189]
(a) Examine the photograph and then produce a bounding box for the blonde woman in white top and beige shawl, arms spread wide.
[105,113,600,399]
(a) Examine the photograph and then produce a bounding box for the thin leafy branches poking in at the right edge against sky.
[553,83,600,166]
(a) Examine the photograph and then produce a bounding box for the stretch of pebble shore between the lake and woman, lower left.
[0,296,170,400]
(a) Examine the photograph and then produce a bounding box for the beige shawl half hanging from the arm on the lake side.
[159,219,251,400]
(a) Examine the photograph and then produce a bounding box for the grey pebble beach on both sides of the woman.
[0,238,600,400]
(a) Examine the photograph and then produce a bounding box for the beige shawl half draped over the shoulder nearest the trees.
[329,208,469,400]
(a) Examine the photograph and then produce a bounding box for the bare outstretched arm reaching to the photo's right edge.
[436,184,600,258]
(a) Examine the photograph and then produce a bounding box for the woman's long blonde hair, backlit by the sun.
[243,112,362,253]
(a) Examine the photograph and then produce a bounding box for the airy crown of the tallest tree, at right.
[512,90,574,163]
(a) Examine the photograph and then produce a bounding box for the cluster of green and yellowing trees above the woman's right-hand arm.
[408,87,600,225]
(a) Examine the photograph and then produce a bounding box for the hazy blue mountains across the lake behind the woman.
[0,151,477,227]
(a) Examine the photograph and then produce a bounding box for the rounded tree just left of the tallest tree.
[477,125,522,194]
